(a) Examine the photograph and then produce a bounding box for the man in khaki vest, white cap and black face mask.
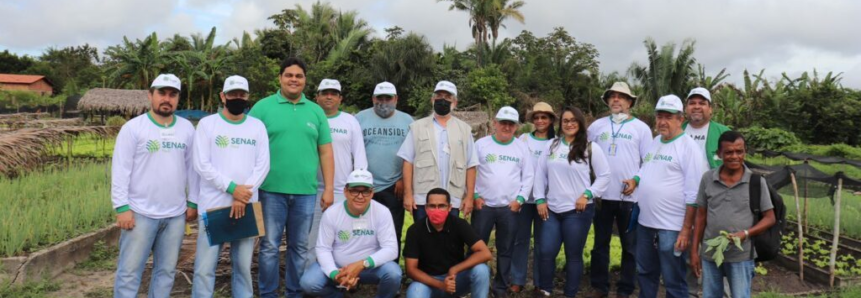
[398,81,478,222]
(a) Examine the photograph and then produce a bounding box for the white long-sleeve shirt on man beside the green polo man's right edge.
[317,112,368,194]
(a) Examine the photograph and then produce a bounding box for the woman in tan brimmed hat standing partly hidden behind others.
[511,102,556,293]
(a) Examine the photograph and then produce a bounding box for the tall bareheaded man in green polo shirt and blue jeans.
[249,57,335,298]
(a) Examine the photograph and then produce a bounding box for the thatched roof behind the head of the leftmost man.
[78,88,150,116]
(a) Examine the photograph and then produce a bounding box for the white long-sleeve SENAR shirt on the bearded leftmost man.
[111,113,199,219]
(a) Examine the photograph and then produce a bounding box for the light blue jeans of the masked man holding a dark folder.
[191,220,254,298]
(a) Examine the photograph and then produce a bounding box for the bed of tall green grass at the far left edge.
[0,163,114,257]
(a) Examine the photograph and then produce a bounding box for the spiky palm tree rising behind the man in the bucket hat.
[628,38,696,104]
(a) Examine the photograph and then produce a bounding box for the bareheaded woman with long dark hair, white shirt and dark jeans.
[533,107,610,297]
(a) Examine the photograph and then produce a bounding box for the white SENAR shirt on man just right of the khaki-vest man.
[475,135,535,207]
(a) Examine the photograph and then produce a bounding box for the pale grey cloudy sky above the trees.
[0,0,861,88]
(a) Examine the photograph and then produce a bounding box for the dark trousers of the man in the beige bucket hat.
[590,200,637,296]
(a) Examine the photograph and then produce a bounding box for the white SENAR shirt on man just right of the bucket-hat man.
[636,133,709,231]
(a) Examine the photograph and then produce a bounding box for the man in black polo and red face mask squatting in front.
[403,188,493,298]
